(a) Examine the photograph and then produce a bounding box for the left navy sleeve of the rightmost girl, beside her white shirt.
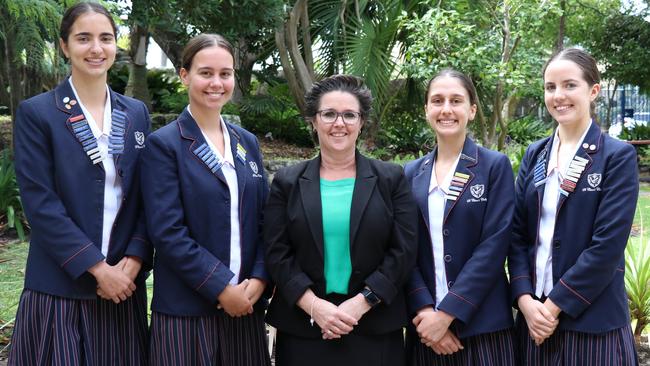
[508,147,534,306]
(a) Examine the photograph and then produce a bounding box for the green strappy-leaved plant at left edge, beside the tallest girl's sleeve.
[0,149,27,240]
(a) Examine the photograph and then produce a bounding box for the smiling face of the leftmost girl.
[59,12,117,80]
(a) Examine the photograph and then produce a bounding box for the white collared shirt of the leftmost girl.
[68,76,122,256]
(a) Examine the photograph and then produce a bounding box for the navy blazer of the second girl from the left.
[142,109,268,316]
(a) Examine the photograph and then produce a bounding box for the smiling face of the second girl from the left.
[180,46,235,112]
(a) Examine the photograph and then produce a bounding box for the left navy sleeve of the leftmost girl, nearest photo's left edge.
[14,101,104,279]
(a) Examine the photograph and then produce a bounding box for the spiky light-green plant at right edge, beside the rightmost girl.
[625,227,650,344]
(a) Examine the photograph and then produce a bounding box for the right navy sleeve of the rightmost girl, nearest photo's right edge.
[549,144,639,318]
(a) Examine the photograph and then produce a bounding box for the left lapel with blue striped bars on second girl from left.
[178,108,228,185]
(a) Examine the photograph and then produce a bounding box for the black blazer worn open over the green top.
[264,152,417,338]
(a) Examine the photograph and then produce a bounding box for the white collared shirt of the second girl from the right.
[427,154,460,309]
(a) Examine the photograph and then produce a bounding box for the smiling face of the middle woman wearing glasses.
[313,91,363,154]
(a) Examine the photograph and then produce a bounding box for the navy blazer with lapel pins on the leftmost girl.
[14,79,152,299]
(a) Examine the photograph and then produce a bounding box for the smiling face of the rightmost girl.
[544,59,600,125]
